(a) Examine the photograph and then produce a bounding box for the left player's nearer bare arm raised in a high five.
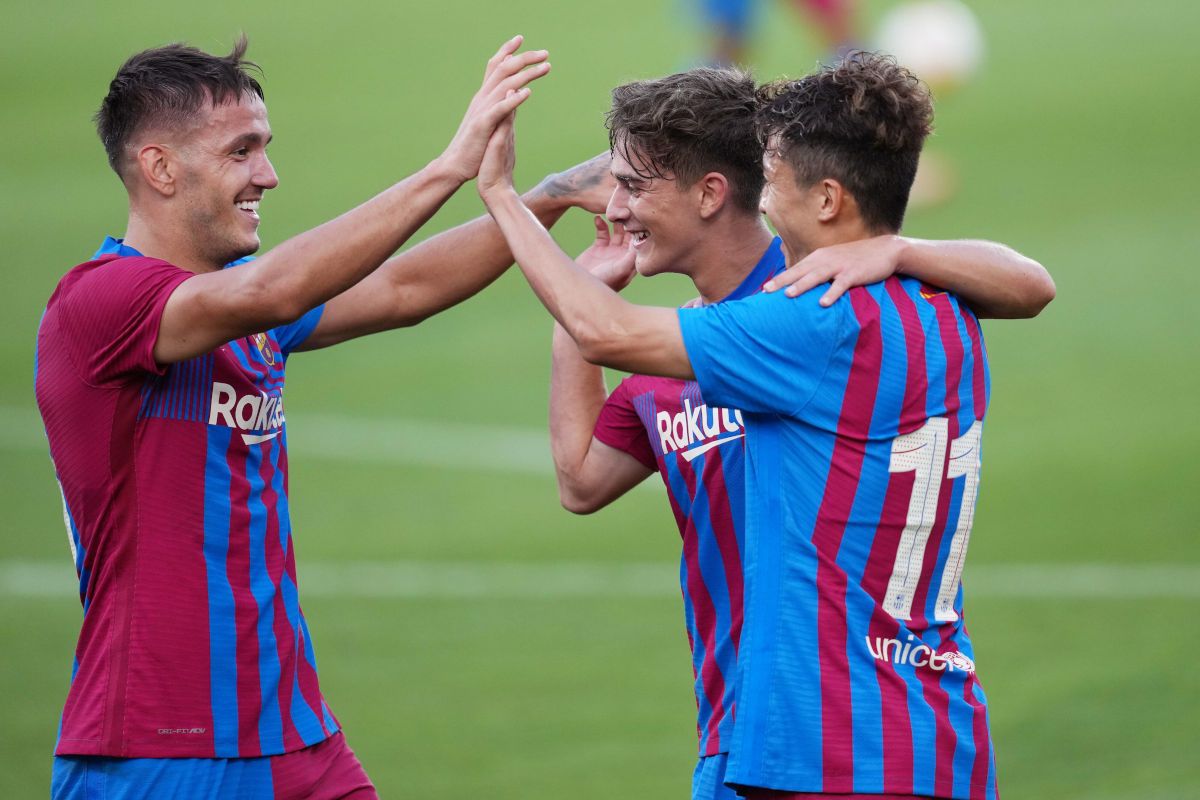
[154,36,550,363]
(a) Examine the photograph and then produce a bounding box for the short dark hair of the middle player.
[606,67,763,212]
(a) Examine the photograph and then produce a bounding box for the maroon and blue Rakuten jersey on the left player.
[35,240,337,757]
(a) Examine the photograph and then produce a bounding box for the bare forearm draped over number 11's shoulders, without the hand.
[898,237,1055,319]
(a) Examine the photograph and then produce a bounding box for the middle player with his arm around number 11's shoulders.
[550,70,1054,800]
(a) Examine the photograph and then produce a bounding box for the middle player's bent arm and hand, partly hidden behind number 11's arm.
[550,217,650,513]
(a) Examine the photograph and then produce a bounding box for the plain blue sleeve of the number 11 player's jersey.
[678,287,848,416]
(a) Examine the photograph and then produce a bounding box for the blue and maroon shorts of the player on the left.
[50,732,378,800]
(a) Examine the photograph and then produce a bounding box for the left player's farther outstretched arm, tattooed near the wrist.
[300,152,613,350]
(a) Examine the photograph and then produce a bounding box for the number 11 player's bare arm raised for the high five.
[475,110,692,379]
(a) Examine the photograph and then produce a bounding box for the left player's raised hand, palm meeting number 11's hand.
[442,36,550,182]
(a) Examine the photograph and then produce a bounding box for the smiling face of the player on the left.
[180,96,280,265]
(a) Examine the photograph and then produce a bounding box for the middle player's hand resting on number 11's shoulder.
[763,234,904,306]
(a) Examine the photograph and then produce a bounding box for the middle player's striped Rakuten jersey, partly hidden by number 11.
[594,239,785,756]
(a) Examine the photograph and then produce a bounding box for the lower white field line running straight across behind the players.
[7,563,1200,600]
